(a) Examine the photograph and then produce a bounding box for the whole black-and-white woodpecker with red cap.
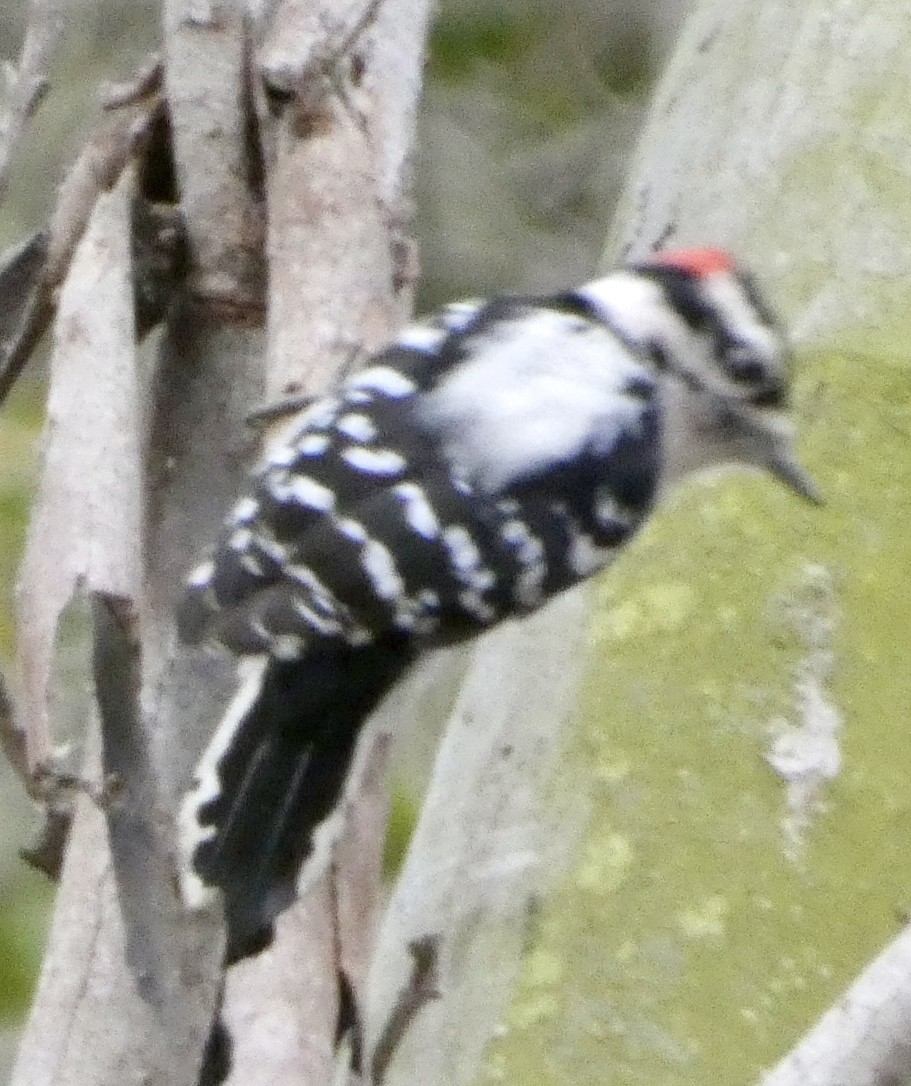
[179,249,815,960]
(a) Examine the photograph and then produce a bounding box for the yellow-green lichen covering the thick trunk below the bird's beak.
[480,343,911,1086]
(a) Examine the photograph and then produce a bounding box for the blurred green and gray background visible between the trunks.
[0,0,688,1068]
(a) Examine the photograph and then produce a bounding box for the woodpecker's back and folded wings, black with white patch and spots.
[178,302,660,659]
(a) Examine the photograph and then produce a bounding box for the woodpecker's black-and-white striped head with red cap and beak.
[579,249,819,501]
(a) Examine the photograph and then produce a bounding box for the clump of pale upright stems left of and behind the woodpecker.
[13,0,428,1086]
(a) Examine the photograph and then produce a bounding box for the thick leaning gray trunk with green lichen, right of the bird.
[371,0,911,1086]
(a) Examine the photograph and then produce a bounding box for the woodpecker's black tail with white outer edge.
[180,643,408,961]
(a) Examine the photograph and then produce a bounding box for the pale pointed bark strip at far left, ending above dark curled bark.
[17,171,141,768]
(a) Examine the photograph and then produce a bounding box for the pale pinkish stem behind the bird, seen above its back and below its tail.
[216,0,436,1086]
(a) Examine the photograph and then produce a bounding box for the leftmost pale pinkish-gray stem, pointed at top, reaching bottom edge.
[14,165,218,1083]
